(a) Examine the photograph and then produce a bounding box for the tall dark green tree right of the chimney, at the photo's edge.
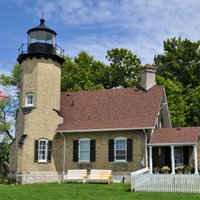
[154,37,200,87]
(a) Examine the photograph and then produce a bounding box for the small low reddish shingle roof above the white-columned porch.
[148,126,200,145]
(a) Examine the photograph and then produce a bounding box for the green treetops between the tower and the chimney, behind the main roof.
[61,48,142,91]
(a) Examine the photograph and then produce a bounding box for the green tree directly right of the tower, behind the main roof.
[61,52,106,91]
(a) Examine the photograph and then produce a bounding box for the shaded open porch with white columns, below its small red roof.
[148,144,199,174]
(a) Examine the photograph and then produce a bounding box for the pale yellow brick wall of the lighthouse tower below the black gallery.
[10,58,63,183]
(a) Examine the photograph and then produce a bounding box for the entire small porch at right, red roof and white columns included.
[148,127,200,174]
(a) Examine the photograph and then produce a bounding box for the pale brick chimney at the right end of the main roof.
[141,64,156,91]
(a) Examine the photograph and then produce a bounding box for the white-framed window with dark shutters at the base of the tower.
[35,139,52,162]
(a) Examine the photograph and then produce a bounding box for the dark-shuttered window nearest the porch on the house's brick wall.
[108,137,133,162]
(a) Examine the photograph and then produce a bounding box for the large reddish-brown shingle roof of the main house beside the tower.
[57,86,164,131]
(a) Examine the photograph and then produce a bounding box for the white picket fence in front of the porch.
[131,174,200,193]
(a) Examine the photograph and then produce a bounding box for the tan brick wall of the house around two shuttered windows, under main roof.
[57,131,145,173]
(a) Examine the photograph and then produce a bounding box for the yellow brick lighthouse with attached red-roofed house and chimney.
[10,19,200,183]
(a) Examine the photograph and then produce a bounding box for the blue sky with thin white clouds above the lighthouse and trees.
[0,0,200,74]
